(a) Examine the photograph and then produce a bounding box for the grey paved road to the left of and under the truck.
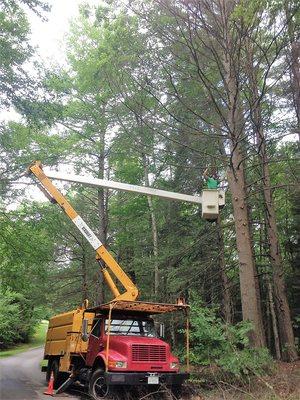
[0,348,83,400]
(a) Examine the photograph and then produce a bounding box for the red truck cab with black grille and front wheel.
[86,312,188,399]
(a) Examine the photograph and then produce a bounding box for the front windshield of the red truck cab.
[105,319,156,337]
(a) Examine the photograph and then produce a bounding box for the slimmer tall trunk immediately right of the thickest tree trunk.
[247,46,298,361]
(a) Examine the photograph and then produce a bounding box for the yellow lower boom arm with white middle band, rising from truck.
[28,161,139,301]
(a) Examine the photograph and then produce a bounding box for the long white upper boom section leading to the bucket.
[45,169,202,204]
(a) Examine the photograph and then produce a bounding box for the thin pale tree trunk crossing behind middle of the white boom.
[142,154,159,301]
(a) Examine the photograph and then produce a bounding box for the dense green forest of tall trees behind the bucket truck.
[0,0,300,382]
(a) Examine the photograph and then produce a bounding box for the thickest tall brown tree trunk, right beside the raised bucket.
[221,0,265,347]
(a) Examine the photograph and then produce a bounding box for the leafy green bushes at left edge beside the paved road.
[0,204,57,348]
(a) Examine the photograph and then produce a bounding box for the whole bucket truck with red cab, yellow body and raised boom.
[28,161,224,400]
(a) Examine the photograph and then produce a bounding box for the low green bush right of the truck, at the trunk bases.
[191,301,272,377]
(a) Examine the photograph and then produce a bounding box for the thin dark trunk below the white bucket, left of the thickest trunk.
[217,216,233,324]
